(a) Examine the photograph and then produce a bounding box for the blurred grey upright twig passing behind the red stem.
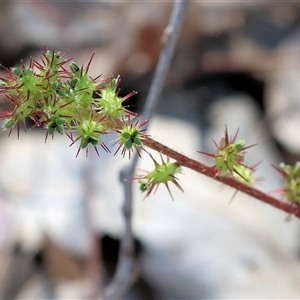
[105,0,188,299]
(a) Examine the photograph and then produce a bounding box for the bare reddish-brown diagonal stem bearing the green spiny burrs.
[143,137,300,218]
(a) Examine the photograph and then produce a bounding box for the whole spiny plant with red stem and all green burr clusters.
[0,48,300,217]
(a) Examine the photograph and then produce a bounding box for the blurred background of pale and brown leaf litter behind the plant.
[0,1,300,299]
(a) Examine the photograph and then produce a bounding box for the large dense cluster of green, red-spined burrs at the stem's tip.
[0,49,146,155]
